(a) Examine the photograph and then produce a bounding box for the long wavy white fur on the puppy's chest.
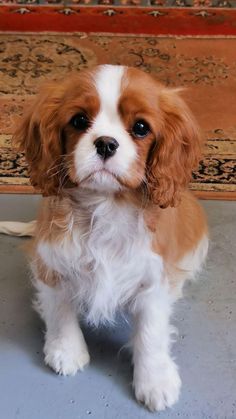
[38,197,162,324]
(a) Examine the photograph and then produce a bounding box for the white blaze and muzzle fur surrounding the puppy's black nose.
[75,65,137,188]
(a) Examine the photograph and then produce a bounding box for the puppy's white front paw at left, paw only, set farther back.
[44,338,90,375]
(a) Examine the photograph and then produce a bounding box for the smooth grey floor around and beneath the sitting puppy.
[0,195,236,419]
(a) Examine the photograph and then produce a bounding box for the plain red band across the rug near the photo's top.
[0,5,236,36]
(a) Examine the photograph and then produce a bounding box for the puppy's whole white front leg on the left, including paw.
[35,280,89,375]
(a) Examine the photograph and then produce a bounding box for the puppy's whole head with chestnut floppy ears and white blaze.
[15,66,200,206]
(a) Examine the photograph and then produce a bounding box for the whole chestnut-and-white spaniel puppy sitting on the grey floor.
[0,65,208,411]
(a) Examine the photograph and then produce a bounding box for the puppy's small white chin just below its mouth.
[80,170,122,193]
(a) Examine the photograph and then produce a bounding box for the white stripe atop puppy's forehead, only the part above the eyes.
[94,65,125,114]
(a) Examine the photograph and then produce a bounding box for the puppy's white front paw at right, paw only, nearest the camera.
[133,359,181,412]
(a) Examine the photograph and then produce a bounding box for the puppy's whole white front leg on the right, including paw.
[133,285,181,411]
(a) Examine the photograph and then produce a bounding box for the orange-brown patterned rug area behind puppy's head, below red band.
[0,33,236,199]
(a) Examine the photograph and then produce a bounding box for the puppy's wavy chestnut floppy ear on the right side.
[147,89,201,208]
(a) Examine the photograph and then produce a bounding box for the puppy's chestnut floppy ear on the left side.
[13,82,66,196]
